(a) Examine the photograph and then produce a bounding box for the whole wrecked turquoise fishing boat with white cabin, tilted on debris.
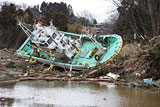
[17,21,123,70]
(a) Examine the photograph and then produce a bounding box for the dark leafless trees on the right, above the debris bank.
[113,0,160,42]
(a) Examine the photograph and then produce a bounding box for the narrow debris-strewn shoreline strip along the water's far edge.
[0,77,160,91]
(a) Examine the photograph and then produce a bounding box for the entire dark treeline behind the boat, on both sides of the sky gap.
[0,0,160,49]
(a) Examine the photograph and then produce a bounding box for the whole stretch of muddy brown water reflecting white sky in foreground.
[0,81,160,107]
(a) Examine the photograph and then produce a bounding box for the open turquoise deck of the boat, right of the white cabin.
[72,37,121,67]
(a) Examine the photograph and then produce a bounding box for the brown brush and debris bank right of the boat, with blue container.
[108,38,160,88]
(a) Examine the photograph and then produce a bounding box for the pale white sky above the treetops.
[0,0,116,23]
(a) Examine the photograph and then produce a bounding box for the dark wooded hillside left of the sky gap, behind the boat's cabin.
[0,2,95,49]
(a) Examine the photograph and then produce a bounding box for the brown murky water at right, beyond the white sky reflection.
[115,86,160,107]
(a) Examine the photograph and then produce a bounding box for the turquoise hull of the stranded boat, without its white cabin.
[17,32,123,70]
